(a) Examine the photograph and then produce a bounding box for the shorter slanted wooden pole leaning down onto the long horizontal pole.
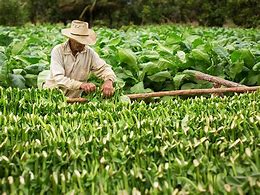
[183,70,246,87]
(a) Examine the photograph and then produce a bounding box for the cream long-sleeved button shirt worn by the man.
[44,41,116,97]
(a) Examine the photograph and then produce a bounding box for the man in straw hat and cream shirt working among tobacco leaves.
[43,20,116,98]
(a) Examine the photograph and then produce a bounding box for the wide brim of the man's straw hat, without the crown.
[61,28,97,45]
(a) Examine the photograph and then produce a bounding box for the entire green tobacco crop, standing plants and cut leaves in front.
[0,25,260,195]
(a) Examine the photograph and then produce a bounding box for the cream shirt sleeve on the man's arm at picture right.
[91,49,116,82]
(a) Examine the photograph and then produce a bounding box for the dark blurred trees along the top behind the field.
[0,0,260,28]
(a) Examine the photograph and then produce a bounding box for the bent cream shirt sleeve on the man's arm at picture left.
[50,47,82,90]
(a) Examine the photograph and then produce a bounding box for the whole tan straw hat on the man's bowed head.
[61,20,96,45]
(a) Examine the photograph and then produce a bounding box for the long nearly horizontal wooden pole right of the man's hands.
[127,86,260,99]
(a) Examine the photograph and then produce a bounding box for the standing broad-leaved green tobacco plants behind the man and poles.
[0,25,260,93]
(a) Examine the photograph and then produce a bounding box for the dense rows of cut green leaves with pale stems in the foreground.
[0,87,260,194]
